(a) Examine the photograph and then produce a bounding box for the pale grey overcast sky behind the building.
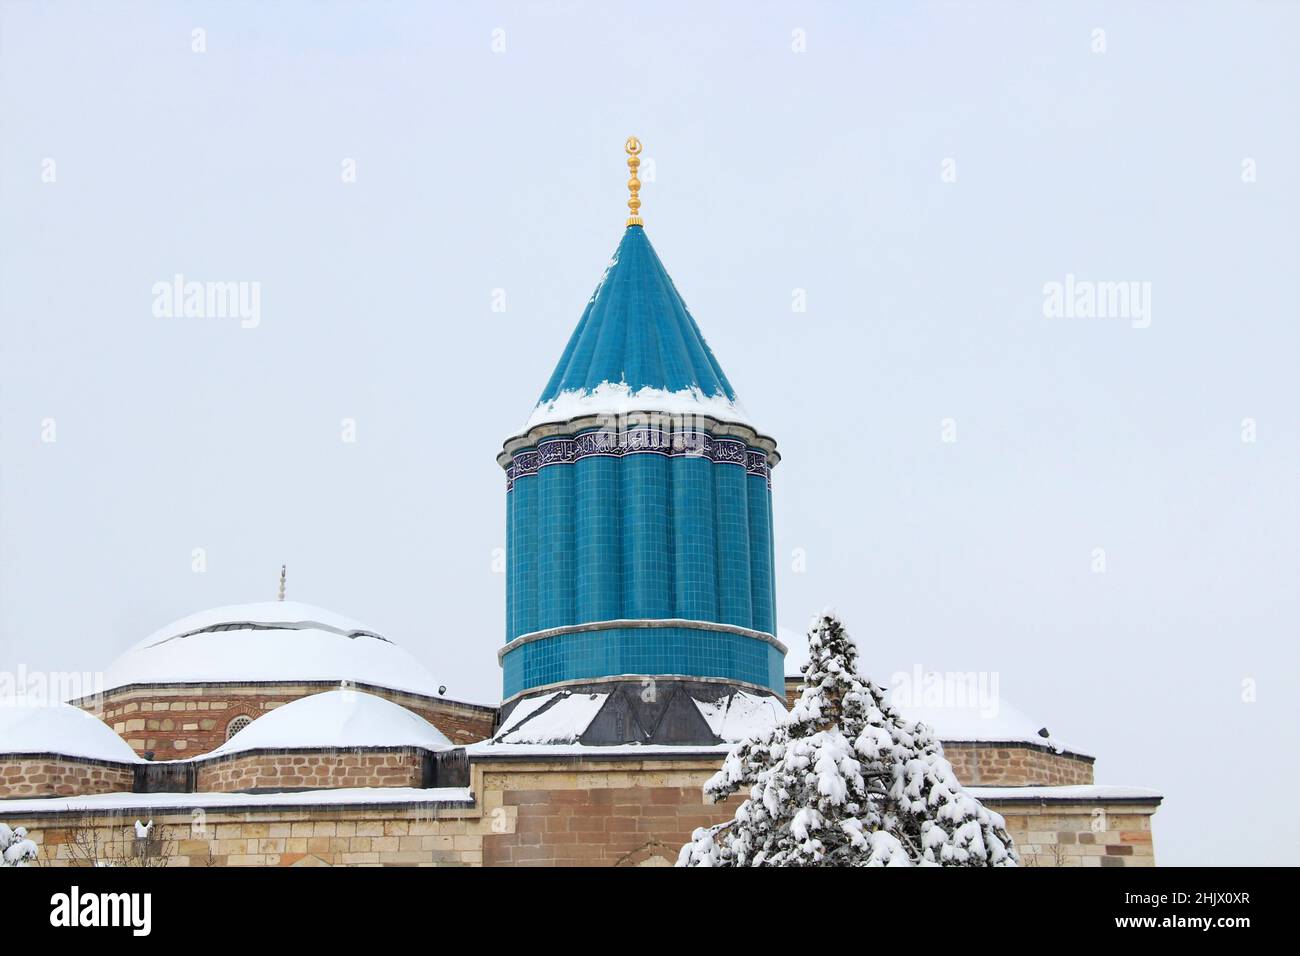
[0,0,1300,864]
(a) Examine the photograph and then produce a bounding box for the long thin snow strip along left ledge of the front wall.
[0,787,473,817]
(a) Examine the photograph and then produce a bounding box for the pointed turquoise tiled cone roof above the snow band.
[538,225,736,407]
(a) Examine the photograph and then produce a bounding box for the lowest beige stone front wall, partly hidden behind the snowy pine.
[0,757,1156,866]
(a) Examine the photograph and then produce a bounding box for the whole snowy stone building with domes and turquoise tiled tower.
[0,139,1161,866]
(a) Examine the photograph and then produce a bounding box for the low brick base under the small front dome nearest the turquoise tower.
[196,748,424,793]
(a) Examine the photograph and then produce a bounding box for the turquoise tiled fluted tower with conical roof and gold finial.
[497,218,785,702]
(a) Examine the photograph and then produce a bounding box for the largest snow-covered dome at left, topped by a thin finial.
[104,601,438,697]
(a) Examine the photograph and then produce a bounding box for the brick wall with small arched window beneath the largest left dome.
[81,683,497,760]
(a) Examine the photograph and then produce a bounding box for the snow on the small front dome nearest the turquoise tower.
[207,689,452,757]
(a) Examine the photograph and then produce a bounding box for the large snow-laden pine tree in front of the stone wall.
[677,611,1018,866]
